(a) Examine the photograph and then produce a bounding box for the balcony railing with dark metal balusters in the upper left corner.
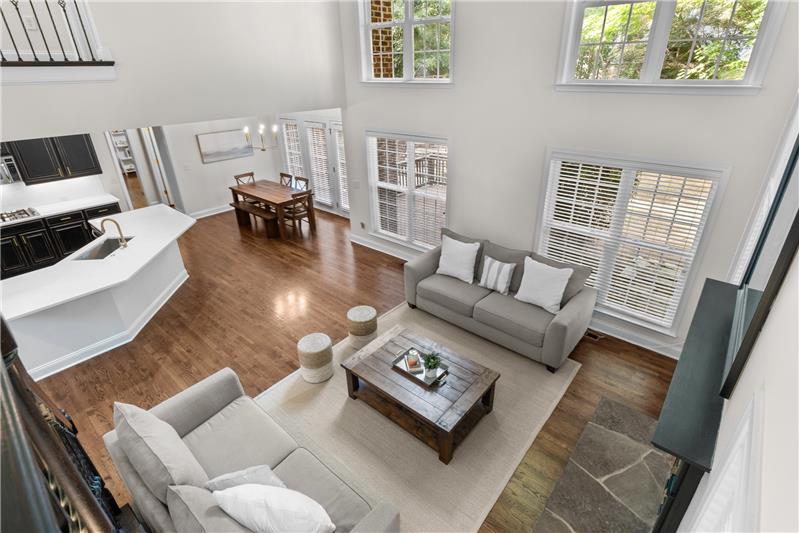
[0,0,114,67]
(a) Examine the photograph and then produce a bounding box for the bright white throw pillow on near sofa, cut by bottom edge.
[214,484,336,533]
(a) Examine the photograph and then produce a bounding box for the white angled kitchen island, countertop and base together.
[0,205,195,379]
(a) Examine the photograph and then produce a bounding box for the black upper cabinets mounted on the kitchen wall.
[5,134,103,185]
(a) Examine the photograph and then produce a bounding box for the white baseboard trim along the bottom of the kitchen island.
[28,269,189,381]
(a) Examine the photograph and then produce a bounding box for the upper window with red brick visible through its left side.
[361,0,452,81]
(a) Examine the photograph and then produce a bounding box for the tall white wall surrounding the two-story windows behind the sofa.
[340,1,798,355]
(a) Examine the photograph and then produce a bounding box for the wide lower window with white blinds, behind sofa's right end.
[539,153,721,329]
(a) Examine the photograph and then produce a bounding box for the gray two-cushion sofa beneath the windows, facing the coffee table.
[404,229,597,372]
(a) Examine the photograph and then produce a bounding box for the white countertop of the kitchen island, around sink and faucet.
[0,204,195,320]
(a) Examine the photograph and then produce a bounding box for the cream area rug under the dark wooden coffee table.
[257,304,580,532]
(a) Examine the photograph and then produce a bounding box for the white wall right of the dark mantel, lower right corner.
[681,255,800,531]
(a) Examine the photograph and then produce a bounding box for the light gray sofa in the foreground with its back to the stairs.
[103,368,398,533]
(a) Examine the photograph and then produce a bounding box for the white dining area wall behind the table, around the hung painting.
[162,117,281,217]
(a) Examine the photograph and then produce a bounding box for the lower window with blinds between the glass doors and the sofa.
[367,133,447,248]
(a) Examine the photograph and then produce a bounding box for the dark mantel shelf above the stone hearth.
[652,279,738,472]
